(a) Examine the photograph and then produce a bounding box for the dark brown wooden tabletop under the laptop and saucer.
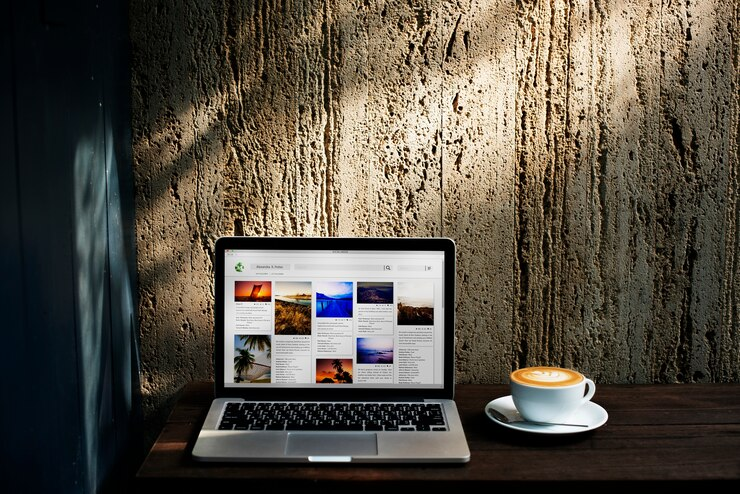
[134,382,740,488]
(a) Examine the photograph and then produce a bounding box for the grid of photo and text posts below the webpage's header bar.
[224,279,441,386]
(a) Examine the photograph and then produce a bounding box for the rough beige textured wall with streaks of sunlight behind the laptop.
[131,0,740,442]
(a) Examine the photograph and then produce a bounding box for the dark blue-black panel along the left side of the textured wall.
[0,0,141,493]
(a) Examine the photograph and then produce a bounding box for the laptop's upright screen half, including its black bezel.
[214,237,455,398]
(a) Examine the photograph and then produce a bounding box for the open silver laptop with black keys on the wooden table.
[192,237,470,463]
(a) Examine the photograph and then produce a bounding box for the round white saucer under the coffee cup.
[485,395,609,434]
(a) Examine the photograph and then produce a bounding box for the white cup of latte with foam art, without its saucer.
[509,366,596,422]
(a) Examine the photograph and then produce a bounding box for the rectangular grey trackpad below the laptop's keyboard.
[286,432,378,456]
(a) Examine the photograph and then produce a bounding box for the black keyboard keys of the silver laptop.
[218,401,447,432]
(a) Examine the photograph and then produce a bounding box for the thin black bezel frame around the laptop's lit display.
[213,236,456,401]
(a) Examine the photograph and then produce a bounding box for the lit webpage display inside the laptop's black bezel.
[222,249,445,388]
